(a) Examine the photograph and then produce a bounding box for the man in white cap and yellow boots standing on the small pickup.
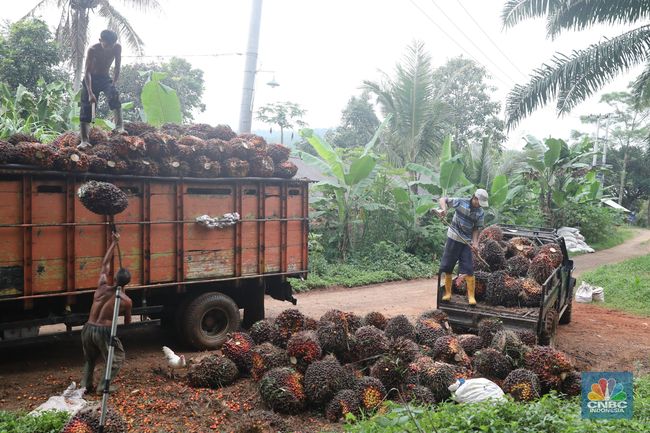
[438,188,488,305]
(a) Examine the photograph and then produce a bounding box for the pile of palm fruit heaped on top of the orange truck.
[0,122,298,179]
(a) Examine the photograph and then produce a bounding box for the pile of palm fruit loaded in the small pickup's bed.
[453,225,564,307]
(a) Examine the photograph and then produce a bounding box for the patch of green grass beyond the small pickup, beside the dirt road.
[581,251,650,316]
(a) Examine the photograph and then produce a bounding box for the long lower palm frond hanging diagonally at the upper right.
[506,26,650,128]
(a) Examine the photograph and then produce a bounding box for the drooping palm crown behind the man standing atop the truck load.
[28,0,161,89]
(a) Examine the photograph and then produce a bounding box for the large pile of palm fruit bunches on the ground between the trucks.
[188,309,580,422]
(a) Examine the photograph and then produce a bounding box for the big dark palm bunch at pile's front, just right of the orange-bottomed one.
[304,355,349,407]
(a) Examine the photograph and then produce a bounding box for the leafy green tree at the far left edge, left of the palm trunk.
[0,19,64,92]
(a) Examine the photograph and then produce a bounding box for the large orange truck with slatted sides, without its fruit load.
[0,166,309,349]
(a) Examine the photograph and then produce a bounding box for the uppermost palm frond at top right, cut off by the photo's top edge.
[546,0,650,38]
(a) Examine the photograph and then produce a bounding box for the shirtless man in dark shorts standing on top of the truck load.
[78,30,124,150]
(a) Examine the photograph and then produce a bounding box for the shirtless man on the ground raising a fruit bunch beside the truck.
[81,233,133,392]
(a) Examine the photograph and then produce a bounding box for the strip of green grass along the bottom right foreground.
[345,376,650,433]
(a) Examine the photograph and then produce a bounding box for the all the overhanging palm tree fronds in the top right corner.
[501,0,650,127]
